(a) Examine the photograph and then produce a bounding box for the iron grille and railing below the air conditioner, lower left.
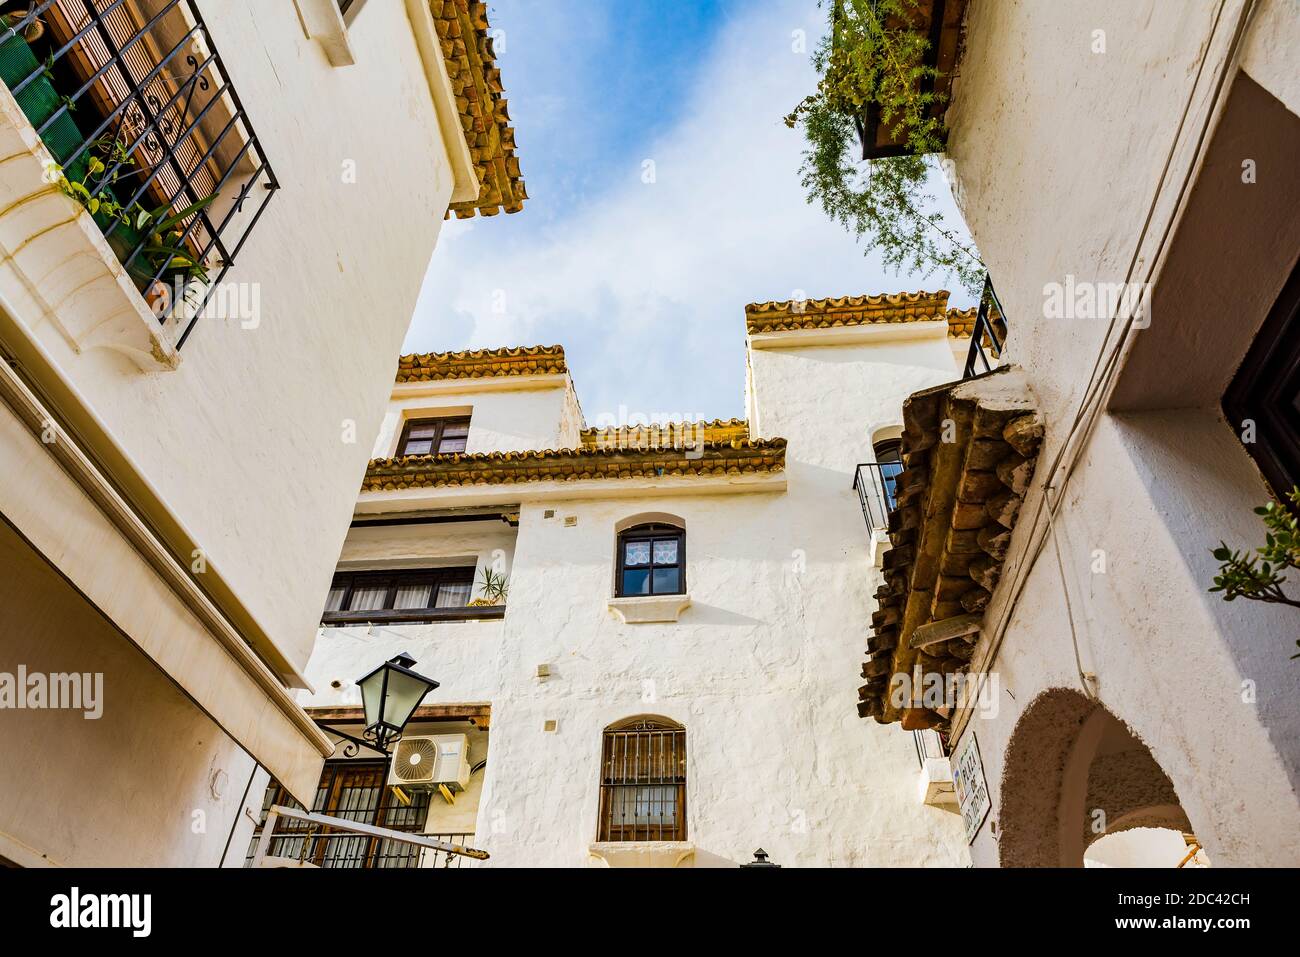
[246,761,473,870]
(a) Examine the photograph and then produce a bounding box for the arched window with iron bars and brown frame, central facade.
[597,716,686,841]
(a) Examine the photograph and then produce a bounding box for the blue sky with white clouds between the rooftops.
[406,0,966,424]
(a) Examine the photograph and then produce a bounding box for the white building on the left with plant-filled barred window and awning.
[0,0,524,866]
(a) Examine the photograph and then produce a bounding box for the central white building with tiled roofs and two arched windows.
[289,293,971,867]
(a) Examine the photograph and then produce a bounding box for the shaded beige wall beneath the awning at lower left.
[0,524,256,867]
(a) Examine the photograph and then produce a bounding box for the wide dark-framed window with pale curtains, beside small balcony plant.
[322,566,478,624]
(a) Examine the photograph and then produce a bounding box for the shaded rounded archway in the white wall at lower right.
[998,688,1192,867]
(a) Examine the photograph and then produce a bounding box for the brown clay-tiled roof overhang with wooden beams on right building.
[858,367,1043,729]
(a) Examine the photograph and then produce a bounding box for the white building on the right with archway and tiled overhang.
[865,0,1300,866]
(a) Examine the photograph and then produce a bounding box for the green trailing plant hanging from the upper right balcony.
[785,0,985,294]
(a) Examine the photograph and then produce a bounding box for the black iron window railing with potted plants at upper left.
[0,0,280,346]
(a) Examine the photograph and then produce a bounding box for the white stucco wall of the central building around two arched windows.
[303,321,966,866]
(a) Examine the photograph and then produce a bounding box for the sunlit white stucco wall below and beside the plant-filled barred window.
[0,0,465,666]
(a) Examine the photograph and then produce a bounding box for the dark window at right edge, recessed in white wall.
[1223,257,1300,507]
